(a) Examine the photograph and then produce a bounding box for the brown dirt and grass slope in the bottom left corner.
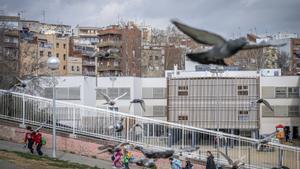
[0,150,99,169]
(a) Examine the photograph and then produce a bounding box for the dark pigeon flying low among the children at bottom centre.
[134,146,174,158]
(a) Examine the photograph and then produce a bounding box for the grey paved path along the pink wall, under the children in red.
[0,140,138,169]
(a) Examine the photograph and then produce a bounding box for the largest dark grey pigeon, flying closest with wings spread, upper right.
[172,20,286,66]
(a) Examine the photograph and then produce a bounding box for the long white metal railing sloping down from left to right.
[0,90,300,169]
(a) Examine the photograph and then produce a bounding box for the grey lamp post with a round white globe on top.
[47,56,60,158]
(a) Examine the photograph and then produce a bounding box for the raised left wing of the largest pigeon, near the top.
[171,20,226,46]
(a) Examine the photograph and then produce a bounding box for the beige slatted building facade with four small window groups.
[168,76,259,136]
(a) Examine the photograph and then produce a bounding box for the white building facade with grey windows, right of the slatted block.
[260,76,300,138]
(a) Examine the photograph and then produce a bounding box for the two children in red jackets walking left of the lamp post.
[24,126,43,156]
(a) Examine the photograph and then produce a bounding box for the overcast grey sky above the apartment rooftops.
[0,0,300,37]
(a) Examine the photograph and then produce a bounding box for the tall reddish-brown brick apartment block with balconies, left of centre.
[98,23,141,77]
